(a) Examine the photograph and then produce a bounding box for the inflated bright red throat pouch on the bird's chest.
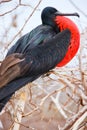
[55,16,80,67]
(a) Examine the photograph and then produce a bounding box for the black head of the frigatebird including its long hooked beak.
[41,7,79,27]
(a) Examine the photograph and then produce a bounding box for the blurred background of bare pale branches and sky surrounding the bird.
[0,0,87,130]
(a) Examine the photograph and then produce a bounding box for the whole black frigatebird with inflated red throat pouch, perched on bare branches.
[0,7,80,111]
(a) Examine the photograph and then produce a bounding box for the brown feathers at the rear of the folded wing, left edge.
[0,53,32,88]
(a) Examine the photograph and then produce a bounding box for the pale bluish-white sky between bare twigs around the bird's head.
[0,0,87,33]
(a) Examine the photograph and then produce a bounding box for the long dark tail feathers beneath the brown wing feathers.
[0,76,39,111]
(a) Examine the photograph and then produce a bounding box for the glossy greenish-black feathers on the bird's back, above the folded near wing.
[7,25,55,56]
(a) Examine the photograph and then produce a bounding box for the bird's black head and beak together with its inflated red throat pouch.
[41,7,80,67]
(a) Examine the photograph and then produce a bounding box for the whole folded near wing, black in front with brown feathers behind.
[0,30,70,88]
